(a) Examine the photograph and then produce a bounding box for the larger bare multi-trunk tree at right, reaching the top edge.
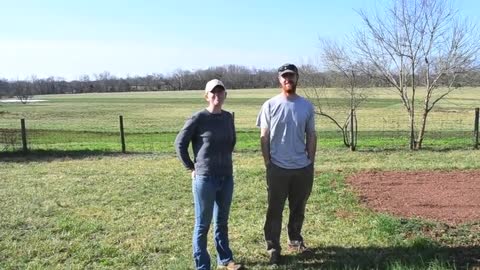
[355,0,480,150]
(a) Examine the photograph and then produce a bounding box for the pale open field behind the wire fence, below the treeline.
[0,88,480,153]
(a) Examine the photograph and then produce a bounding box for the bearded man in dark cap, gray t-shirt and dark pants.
[257,64,317,264]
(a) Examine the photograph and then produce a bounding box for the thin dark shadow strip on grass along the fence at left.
[0,150,167,163]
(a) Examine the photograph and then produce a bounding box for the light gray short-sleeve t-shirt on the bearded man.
[257,94,315,169]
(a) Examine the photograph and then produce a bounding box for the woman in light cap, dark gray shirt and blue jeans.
[175,79,242,269]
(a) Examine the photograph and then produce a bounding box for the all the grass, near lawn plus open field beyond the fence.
[0,89,480,269]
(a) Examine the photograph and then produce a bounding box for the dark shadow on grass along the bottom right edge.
[245,246,480,270]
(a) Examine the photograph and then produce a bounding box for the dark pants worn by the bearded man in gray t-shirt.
[263,163,313,252]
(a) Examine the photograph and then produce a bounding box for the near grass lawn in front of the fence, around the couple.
[0,149,480,269]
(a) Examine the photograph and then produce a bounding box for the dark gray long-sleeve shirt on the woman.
[175,109,236,176]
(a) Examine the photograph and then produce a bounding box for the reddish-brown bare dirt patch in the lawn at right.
[347,170,480,225]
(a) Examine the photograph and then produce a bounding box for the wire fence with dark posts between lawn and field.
[0,108,479,154]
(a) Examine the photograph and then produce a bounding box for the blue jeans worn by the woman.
[192,175,233,270]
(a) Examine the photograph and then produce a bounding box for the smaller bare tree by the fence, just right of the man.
[301,40,369,151]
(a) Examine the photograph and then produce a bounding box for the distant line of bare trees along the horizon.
[0,65,480,98]
